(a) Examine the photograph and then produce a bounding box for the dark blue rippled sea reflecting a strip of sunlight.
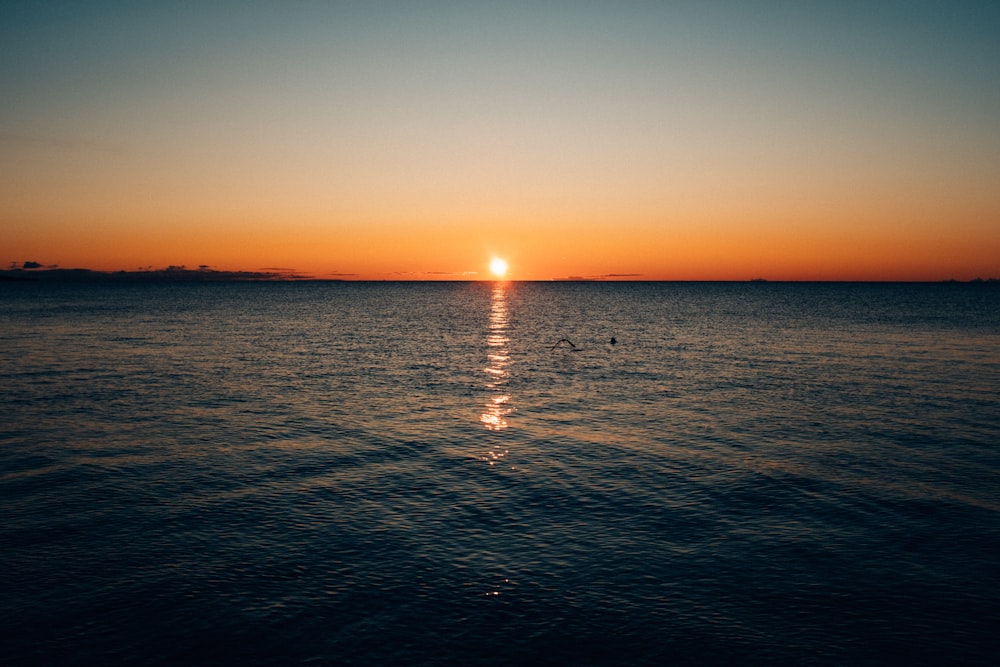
[0,283,1000,665]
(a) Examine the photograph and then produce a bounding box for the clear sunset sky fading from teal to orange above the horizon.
[0,0,1000,280]
